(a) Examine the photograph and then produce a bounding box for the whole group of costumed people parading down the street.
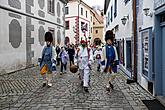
[38,31,119,92]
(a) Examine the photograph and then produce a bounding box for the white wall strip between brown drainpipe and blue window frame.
[137,0,154,90]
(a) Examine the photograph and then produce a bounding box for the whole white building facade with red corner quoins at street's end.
[65,0,93,44]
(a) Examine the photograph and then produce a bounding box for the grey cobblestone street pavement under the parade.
[0,65,154,110]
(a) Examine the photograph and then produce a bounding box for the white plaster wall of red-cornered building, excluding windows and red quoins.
[65,1,91,44]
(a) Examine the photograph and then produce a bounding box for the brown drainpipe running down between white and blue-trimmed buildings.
[127,0,137,84]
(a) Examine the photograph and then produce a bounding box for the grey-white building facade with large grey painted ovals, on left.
[0,0,67,74]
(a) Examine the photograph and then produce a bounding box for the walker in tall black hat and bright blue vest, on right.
[101,31,118,91]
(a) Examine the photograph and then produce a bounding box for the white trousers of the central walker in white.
[79,69,89,87]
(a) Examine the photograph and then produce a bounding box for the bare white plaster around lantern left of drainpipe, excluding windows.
[105,0,133,76]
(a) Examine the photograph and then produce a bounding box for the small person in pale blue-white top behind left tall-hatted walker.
[59,47,68,75]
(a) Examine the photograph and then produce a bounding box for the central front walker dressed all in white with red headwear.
[74,40,93,92]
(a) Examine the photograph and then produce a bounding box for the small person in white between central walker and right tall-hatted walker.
[94,45,102,72]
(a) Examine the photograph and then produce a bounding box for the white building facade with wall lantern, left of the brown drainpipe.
[104,0,133,77]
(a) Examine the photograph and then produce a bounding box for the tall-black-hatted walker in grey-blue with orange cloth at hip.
[39,32,56,87]
